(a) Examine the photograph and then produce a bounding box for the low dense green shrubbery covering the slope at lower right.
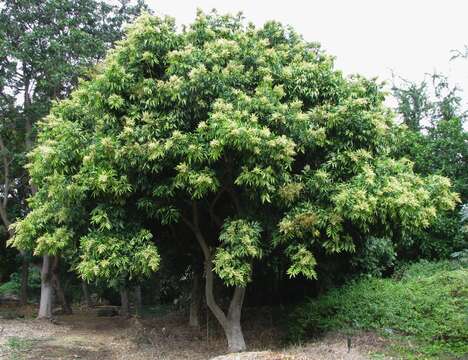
[289,261,468,356]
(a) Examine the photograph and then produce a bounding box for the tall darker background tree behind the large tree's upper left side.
[0,0,145,310]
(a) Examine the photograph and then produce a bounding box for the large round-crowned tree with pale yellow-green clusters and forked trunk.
[12,13,457,351]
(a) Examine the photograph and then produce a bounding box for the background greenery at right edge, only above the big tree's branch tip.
[393,75,468,203]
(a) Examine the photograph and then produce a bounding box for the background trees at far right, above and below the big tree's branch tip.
[393,74,468,259]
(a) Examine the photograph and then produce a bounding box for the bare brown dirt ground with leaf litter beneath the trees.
[0,309,392,360]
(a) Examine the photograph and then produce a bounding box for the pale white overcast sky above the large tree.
[148,0,468,104]
